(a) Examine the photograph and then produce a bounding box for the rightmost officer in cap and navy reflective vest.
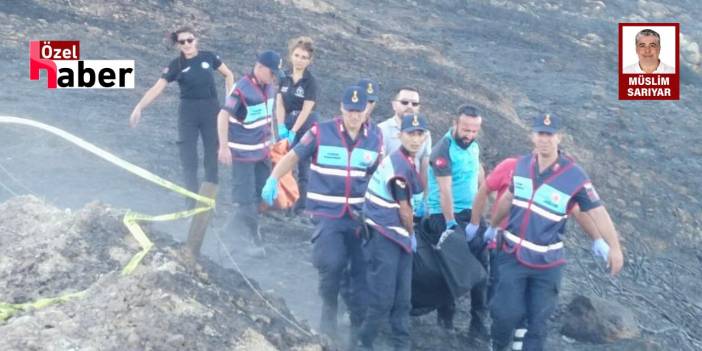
[484,114,624,351]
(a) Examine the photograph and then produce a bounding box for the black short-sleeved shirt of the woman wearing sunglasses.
[161,50,222,99]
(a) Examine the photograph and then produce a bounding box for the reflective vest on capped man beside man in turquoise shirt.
[363,149,423,253]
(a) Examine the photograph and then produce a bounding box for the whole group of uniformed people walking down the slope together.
[130,28,623,351]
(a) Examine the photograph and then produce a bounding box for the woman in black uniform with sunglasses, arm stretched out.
[129,27,234,199]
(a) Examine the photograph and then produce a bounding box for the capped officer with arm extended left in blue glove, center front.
[261,86,383,344]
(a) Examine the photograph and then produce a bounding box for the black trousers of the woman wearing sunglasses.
[176,99,219,193]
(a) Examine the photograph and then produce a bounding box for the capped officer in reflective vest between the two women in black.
[217,51,282,255]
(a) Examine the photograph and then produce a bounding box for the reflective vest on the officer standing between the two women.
[229,74,275,162]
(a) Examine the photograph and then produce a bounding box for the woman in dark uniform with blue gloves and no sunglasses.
[276,37,317,214]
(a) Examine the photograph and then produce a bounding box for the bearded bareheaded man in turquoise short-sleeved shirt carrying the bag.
[425,105,488,337]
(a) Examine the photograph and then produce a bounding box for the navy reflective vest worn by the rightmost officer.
[503,155,590,268]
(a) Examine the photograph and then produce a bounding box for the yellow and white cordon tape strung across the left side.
[0,116,215,321]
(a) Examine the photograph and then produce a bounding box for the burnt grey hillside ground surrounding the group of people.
[0,0,702,350]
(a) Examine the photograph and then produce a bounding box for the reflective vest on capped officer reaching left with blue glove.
[306,118,383,218]
